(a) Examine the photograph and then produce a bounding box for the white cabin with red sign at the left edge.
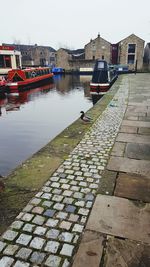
[0,45,21,74]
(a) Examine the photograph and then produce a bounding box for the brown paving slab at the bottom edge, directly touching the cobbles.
[72,231,104,267]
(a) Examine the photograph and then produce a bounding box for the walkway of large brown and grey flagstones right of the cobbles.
[73,74,150,267]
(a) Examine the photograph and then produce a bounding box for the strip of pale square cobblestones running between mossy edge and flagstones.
[0,77,128,267]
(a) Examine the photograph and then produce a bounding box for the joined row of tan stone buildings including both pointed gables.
[56,34,144,70]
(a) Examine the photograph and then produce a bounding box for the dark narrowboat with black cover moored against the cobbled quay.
[90,59,117,95]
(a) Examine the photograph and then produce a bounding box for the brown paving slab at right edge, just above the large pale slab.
[114,173,150,202]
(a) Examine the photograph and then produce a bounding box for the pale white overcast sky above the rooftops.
[0,0,150,49]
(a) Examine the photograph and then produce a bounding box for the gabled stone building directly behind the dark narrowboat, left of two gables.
[84,34,111,63]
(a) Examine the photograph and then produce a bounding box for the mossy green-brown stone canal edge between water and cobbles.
[0,77,122,233]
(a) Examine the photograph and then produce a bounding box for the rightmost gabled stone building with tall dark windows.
[118,34,145,70]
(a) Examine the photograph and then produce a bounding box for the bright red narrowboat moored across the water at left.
[6,67,53,92]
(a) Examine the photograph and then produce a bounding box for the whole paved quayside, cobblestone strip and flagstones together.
[0,74,150,267]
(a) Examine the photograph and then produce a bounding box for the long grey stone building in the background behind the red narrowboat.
[2,44,55,67]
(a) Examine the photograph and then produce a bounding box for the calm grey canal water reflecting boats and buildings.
[0,75,93,176]
